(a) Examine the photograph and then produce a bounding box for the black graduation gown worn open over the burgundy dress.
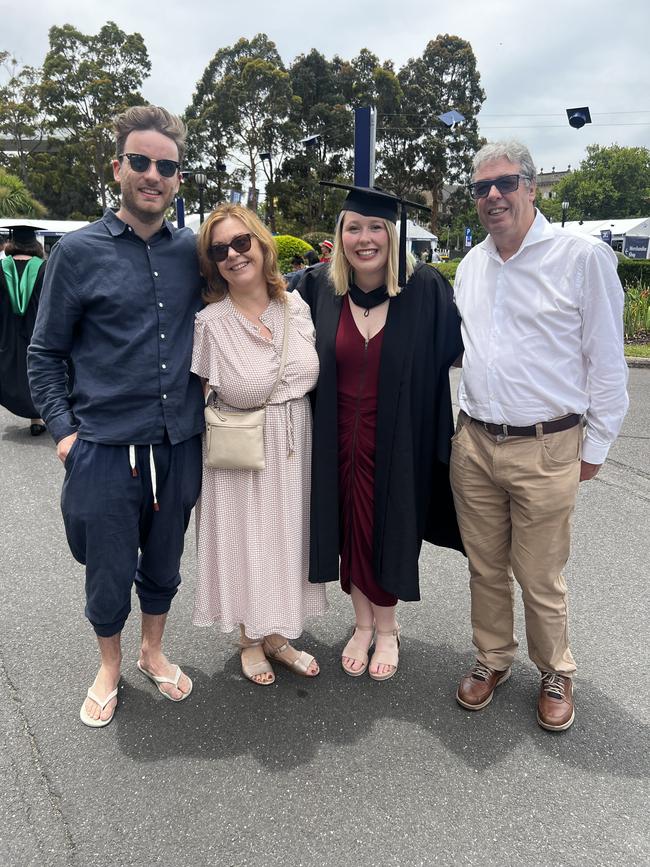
[297,265,463,600]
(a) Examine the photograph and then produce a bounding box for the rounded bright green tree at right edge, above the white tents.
[554,144,650,220]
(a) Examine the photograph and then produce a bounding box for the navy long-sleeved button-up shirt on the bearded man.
[28,210,203,445]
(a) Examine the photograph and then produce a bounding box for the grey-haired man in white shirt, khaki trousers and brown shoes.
[451,142,628,731]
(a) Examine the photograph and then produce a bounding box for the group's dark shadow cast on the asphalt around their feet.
[109,633,649,778]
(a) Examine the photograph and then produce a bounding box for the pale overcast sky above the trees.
[0,0,650,177]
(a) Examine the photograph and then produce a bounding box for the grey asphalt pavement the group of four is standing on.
[0,368,650,867]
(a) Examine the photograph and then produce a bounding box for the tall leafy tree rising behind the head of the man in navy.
[40,21,151,214]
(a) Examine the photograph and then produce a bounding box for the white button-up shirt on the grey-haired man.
[454,212,628,464]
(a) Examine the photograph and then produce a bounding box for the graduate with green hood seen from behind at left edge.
[0,226,45,436]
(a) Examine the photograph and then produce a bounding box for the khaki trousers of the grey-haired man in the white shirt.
[451,411,583,676]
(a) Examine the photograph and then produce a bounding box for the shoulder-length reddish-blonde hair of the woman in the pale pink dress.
[198,204,287,304]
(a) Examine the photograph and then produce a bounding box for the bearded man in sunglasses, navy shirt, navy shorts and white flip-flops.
[28,106,203,727]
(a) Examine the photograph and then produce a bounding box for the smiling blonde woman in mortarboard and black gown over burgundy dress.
[298,184,462,680]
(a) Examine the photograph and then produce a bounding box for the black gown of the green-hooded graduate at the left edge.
[0,259,45,418]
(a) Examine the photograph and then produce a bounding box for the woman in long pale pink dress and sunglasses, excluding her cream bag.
[192,205,327,685]
